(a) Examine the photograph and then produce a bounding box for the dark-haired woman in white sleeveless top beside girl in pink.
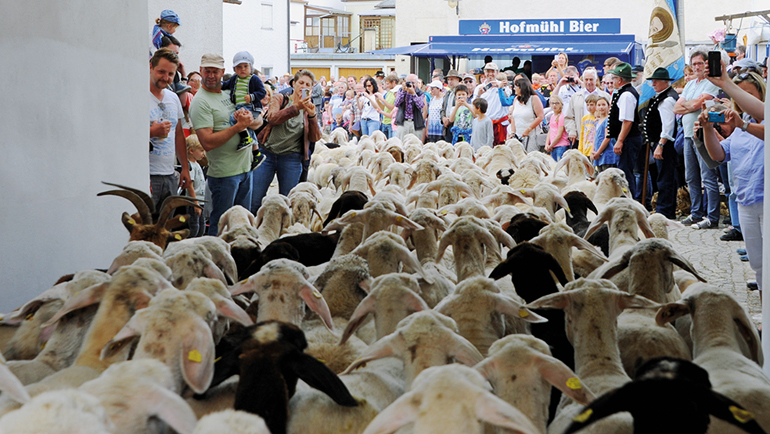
[499,75,544,152]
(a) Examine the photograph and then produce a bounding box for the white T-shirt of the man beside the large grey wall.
[150,89,184,175]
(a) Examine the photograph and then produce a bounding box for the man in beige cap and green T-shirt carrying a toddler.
[190,53,256,236]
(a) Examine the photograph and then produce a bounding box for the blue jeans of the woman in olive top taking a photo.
[251,150,302,214]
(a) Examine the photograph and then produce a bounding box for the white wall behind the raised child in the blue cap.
[147,0,222,78]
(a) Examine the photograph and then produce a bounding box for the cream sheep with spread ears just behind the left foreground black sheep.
[230,259,334,330]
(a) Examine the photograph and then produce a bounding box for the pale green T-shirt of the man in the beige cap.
[190,87,253,178]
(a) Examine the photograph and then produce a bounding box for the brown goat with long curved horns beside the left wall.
[97,182,200,249]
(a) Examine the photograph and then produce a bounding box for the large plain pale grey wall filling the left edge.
[0,0,149,312]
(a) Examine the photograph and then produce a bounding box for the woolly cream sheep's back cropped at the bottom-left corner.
[0,389,114,434]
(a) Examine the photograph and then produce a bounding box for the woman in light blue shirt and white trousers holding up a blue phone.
[696,72,765,289]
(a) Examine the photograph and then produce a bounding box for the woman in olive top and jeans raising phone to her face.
[251,69,321,208]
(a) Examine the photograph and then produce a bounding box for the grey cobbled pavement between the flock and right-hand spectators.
[669,222,762,327]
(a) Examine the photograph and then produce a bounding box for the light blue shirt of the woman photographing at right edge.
[721,122,765,206]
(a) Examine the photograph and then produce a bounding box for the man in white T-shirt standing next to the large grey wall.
[150,48,190,208]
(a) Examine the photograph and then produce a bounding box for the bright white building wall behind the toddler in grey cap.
[223,0,291,76]
